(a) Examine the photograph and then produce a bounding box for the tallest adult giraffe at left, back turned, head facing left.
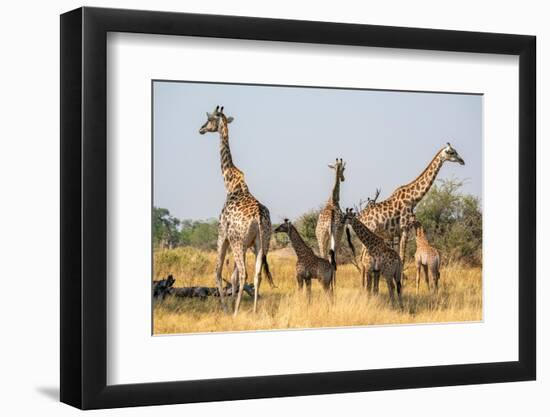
[199,106,273,315]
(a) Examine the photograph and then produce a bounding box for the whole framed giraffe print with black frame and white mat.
[61,8,536,409]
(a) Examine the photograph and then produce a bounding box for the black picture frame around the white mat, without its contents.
[60,7,536,409]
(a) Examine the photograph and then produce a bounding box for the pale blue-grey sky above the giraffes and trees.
[153,81,482,223]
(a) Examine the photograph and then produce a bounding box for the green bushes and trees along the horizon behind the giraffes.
[153,179,482,265]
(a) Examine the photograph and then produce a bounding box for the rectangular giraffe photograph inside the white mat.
[151,80,483,335]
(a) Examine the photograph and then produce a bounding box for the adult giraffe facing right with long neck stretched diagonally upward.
[359,142,464,265]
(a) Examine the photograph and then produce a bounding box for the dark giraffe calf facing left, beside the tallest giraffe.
[275,219,336,298]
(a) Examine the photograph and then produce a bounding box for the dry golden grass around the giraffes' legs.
[153,248,482,334]
